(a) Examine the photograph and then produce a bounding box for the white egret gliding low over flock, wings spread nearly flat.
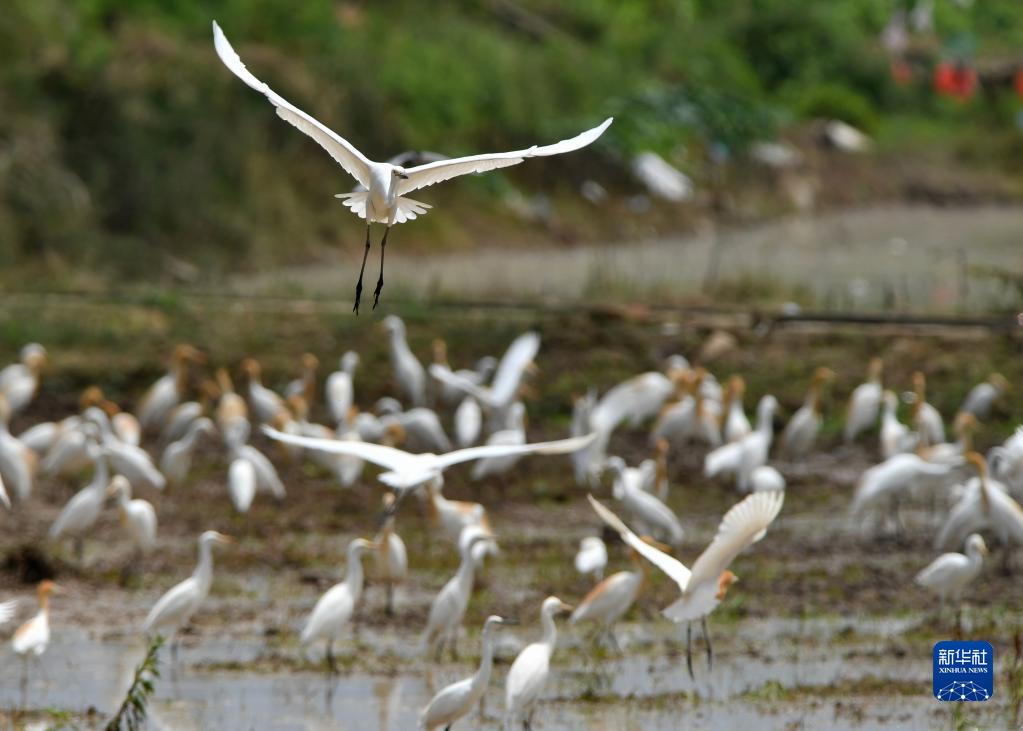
[263,426,594,509]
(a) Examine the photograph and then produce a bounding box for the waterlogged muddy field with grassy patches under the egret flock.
[0,299,1023,731]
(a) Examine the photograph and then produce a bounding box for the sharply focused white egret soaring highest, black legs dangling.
[207,20,611,314]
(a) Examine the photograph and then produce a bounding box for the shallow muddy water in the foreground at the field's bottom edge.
[0,619,990,731]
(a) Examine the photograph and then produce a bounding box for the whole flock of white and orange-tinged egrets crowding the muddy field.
[0,316,1023,729]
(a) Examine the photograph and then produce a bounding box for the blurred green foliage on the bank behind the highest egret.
[0,0,1023,277]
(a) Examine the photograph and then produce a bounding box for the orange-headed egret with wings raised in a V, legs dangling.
[586,491,785,677]
